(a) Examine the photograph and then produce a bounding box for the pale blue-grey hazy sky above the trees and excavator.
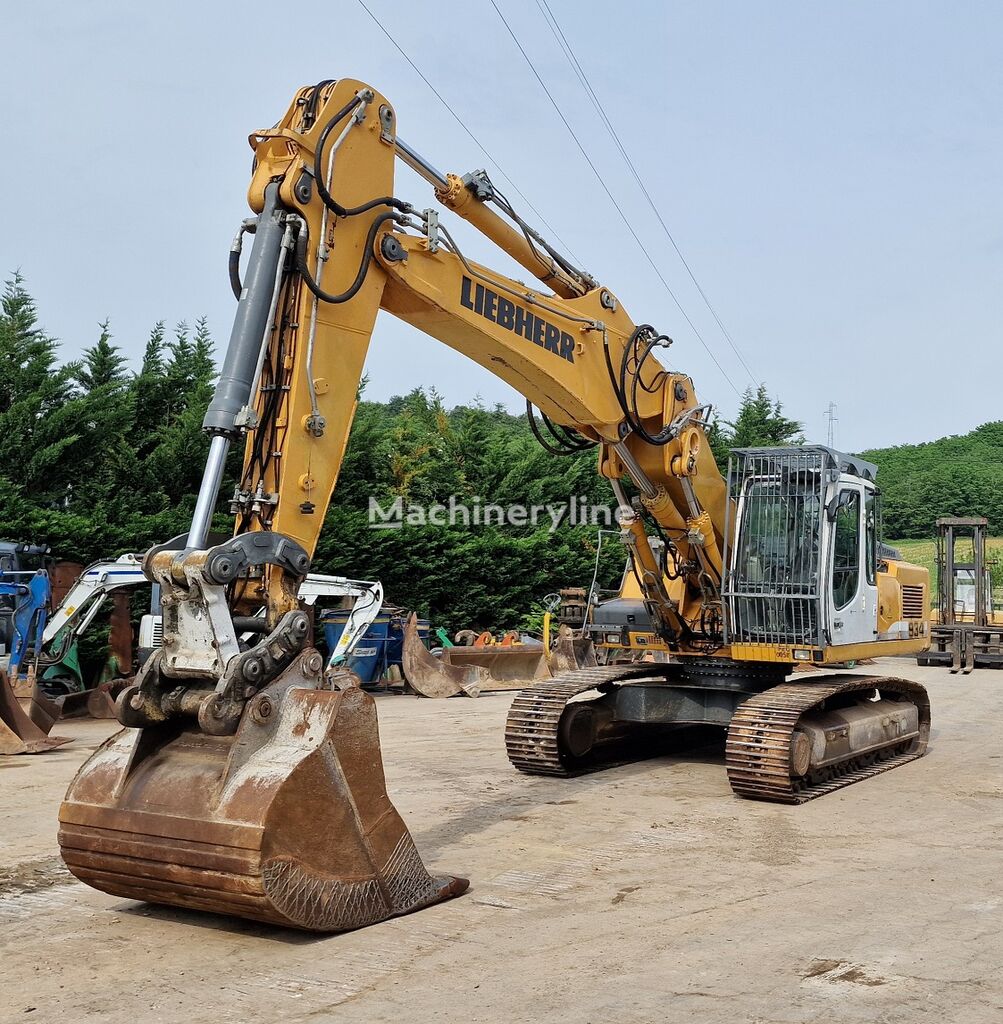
[0,0,1003,451]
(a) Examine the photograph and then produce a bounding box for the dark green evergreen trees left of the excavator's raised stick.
[0,275,226,562]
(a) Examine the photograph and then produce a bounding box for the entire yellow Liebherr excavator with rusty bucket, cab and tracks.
[59,79,929,932]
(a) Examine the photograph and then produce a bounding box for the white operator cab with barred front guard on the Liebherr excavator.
[723,445,879,660]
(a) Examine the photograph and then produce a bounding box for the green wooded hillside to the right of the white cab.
[861,421,1003,538]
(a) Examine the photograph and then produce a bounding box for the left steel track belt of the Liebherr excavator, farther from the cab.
[505,663,678,777]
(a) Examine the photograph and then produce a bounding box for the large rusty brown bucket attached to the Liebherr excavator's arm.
[59,652,467,932]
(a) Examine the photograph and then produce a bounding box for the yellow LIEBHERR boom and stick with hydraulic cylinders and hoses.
[214,80,726,650]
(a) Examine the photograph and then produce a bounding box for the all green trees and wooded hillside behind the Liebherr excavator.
[13,264,987,627]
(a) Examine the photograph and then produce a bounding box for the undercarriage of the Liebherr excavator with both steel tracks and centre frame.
[505,659,930,804]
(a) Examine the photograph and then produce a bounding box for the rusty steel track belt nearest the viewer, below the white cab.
[725,676,930,804]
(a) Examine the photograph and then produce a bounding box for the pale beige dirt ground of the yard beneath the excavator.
[0,660,1003,1024]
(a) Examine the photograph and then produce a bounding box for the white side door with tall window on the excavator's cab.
[827,479,878,646]
